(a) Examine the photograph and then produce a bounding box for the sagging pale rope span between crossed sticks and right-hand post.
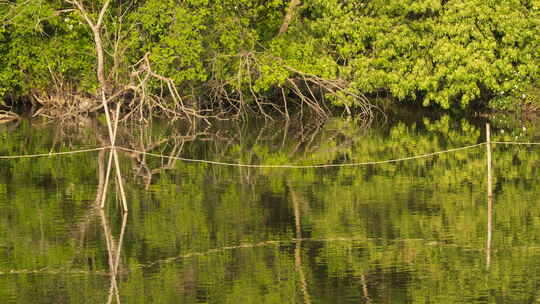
[117,142,486,169]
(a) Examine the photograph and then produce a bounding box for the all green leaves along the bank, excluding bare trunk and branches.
[0,0,540,108]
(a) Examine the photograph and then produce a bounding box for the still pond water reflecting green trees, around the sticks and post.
[0,115,540,303]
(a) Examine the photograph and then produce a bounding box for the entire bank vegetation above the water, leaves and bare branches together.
[0,0,540,121]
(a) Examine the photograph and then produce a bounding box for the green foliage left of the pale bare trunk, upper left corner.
[0,0,95,99]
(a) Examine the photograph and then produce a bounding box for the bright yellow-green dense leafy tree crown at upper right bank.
[313,0,540,108]
